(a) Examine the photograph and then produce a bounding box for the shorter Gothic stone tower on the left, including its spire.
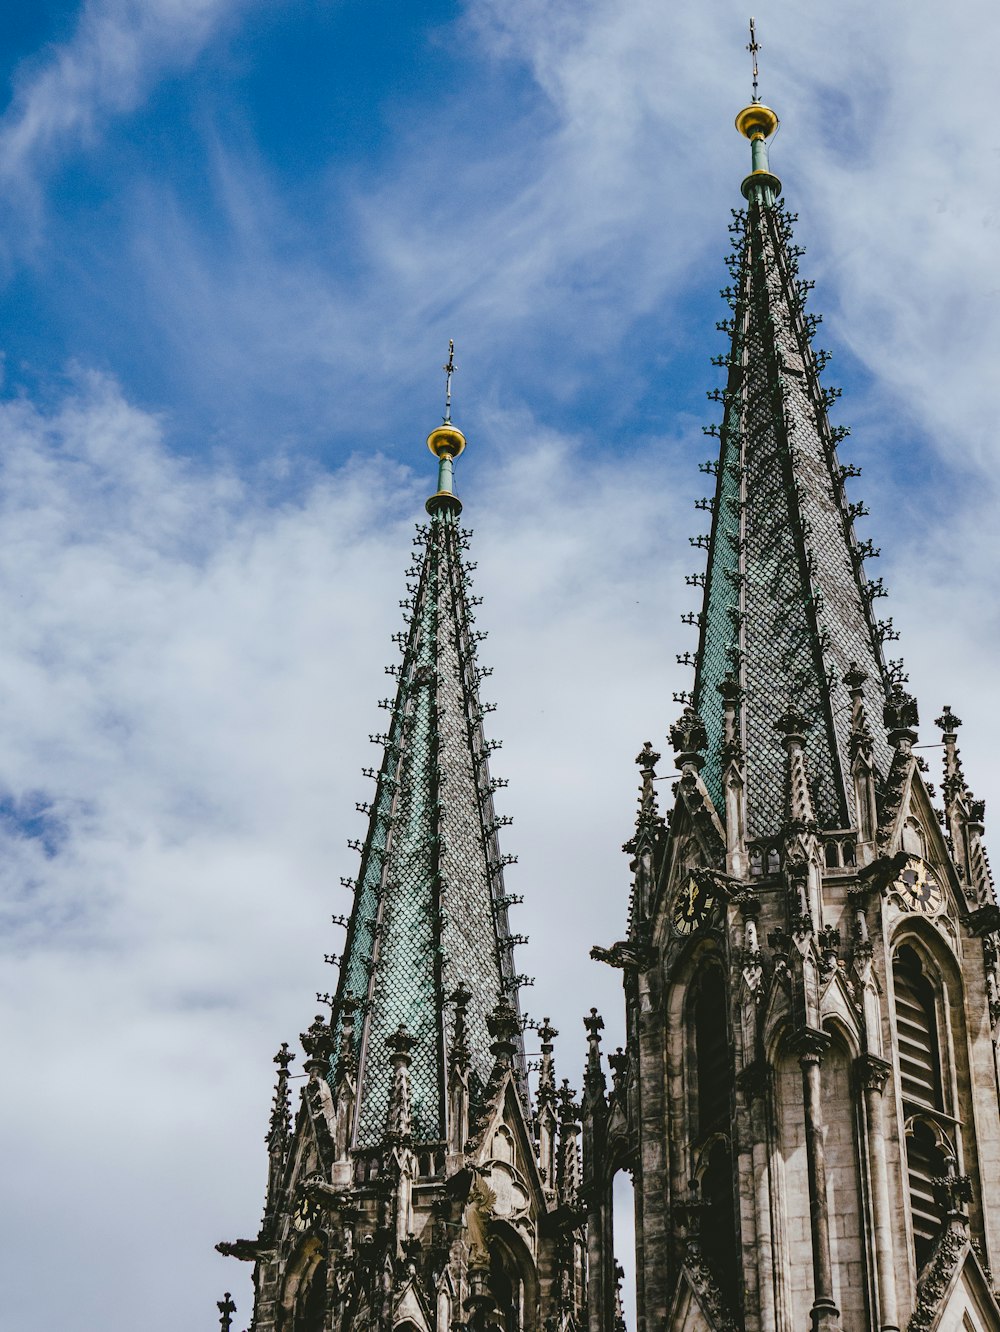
[218,394,583,1332]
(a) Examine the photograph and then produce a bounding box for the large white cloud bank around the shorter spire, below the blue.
[0,377,697,1329]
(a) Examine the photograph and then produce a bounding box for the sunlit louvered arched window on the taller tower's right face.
[892,947,947,1272]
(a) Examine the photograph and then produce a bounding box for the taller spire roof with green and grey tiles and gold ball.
[688,101,895,836]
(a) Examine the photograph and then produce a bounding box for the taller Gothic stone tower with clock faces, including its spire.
[583,100,1000,1332]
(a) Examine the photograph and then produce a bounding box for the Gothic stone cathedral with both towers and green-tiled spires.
[218,88,1000,1332]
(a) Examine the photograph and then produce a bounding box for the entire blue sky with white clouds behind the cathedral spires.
[0,0,1000,1332]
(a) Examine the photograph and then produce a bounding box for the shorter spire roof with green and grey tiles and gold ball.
[334,383,523,1147]
